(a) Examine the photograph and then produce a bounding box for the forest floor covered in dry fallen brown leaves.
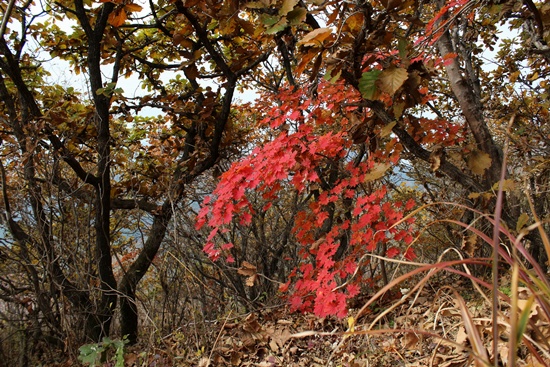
[45,272,550,367]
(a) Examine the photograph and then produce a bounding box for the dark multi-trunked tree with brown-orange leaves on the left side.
[0,0,269,348]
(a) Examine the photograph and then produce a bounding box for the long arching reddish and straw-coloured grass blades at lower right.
[293,197,550,367]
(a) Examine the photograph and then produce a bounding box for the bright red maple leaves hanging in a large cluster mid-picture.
[196,83,415,317]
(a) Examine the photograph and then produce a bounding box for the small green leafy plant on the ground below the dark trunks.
[78,337,128,367]
